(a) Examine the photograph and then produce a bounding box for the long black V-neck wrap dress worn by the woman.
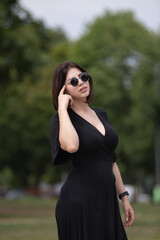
[50,108,127,240]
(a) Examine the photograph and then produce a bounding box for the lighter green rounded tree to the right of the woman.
[70,12,160,183]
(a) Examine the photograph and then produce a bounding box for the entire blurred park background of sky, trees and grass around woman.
[0,0,160,240]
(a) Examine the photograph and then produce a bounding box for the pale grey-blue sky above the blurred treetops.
[20,0,160,40]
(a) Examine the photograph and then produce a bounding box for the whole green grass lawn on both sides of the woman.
[0,198,160,240]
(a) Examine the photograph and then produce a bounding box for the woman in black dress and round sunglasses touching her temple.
[50,62,134,240]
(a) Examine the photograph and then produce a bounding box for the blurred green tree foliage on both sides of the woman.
[0,0,160,186]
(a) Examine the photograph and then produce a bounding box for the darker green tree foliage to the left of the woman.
[0,0,68,186]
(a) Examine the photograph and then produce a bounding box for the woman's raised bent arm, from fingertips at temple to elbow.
[58,85,79,153]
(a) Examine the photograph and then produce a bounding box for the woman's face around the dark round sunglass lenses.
[65,68,90,100]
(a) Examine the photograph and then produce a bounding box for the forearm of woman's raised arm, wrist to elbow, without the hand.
[58,109,79,153]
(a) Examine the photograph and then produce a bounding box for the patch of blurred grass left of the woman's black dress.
[0,198,58,240]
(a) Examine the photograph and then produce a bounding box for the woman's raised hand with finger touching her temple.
[58,85,73,110]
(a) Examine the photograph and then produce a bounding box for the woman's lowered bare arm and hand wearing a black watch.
[113,162,134,227]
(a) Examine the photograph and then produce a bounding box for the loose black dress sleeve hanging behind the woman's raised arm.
[50,113,69,165]
